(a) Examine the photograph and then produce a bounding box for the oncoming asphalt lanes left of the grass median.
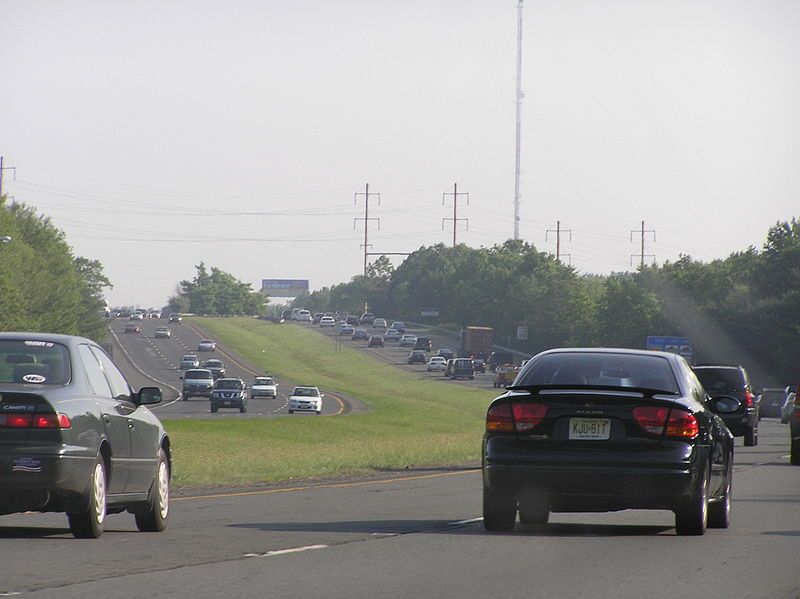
[109,318,366,419]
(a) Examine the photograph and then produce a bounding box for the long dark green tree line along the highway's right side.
[294,218,800,385]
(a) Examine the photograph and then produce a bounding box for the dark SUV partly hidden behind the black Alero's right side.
[692,365,758,447]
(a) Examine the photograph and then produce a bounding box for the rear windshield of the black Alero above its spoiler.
[517,353,679,393]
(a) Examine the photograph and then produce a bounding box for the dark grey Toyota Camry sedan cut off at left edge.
[0,333,172,538]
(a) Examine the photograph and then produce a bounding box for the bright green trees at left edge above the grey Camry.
[0,198,111,341]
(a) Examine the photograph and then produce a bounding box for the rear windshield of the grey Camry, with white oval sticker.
[0,339,70,385]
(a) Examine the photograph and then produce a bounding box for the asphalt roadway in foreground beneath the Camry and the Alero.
[0,420,800,599]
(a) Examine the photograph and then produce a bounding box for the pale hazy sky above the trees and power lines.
[0,0,800,307]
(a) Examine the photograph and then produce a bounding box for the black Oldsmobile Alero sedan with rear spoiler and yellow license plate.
[482,349,739,535]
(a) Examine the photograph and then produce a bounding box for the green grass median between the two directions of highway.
[164,318,493,487]
